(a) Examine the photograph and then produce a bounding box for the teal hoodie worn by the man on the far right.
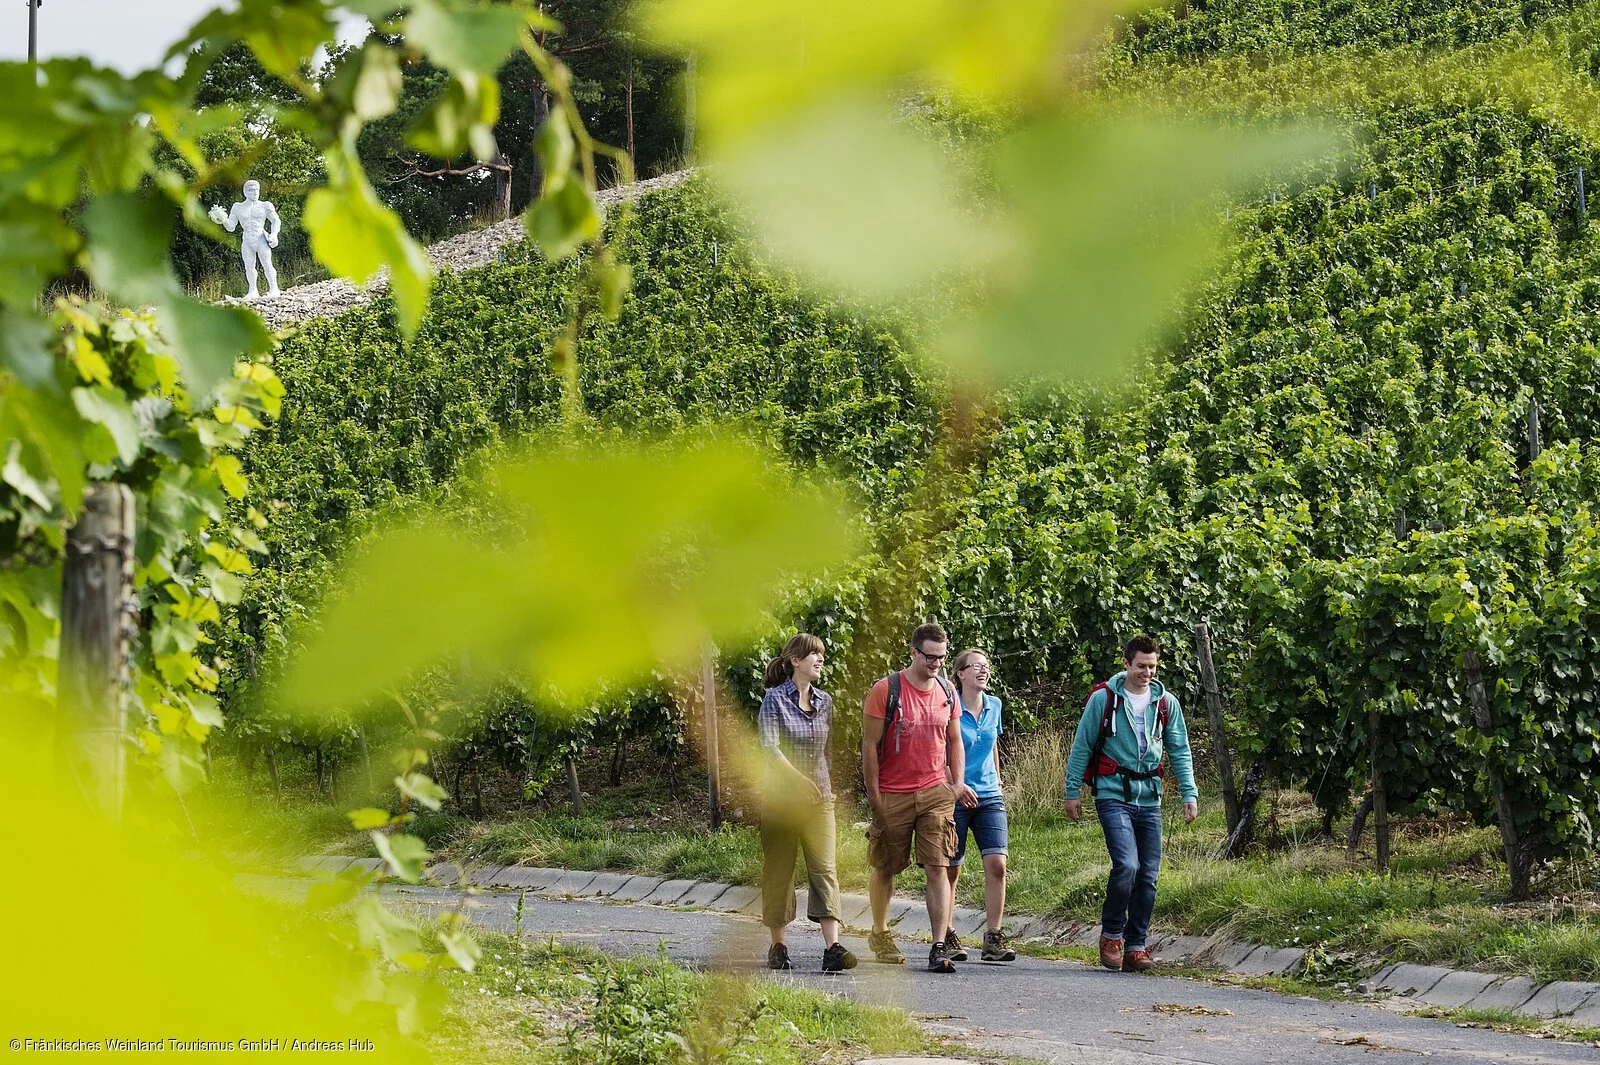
[1067,672,1200,806]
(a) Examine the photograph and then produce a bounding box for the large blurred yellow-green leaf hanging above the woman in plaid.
[285,441,853,708]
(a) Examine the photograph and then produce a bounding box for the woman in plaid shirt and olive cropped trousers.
[755,632,856,972]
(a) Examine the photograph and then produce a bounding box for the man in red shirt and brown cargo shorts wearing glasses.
[861,625,978,972]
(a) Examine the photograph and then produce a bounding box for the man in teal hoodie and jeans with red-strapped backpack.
[1066,636,1200,972]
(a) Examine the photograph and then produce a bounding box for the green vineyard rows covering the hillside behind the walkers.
[187,3,1600,901]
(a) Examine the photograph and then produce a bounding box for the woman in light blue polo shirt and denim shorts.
[944,649,1016,961]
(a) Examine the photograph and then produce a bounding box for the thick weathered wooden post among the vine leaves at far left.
[56,485,134,817]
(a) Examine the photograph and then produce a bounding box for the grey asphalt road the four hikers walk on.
[394,888,1600,1065]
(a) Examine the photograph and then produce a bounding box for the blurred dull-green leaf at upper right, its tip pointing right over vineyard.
[941,115,1334,379]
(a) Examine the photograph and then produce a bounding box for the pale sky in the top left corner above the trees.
[0,0,366,74]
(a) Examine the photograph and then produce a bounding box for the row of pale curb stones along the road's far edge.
[321,856,1600,1027]
